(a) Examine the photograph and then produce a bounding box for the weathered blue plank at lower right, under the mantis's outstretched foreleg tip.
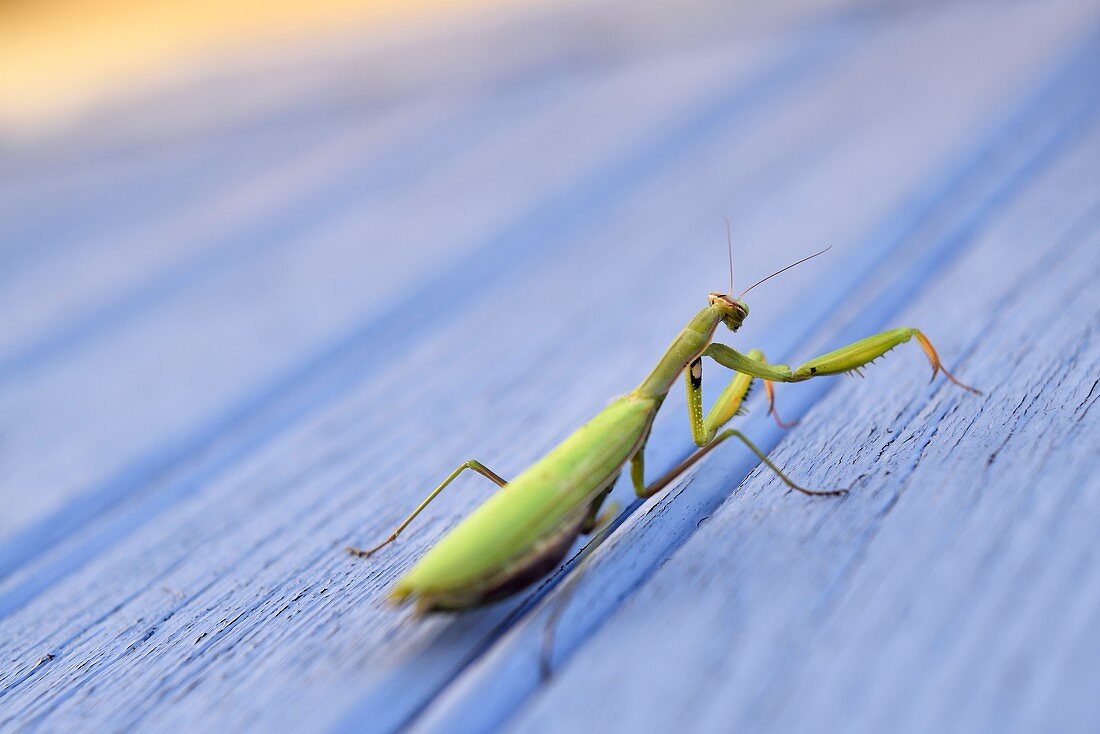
[417,31,1100,732]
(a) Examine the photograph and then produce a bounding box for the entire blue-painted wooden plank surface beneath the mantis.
[0,0,1100,732]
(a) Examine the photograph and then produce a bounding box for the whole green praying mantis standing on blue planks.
[349,236,980,612]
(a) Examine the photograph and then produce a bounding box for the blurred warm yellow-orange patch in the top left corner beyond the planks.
[0,0,512,129]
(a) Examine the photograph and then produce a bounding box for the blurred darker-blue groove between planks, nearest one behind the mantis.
[0,21,851,618]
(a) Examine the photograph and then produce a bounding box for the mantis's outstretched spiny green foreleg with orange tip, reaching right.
[703,328,981,395]
